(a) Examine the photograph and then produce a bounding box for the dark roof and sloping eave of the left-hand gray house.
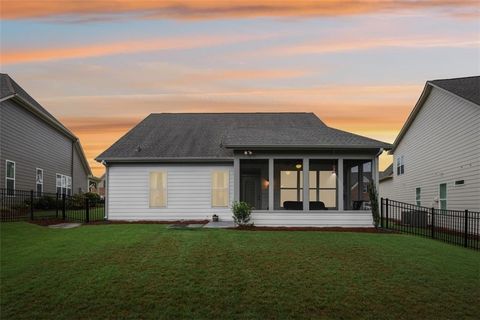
[0,73,92,175]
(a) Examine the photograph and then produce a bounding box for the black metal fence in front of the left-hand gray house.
[0,189,105,223]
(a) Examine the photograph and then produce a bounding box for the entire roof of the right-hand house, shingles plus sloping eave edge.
[390,76,480,153]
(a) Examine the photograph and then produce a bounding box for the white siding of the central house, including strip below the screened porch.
[107,164,373,227]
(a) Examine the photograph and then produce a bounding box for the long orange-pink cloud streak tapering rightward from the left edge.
[0,35,273,64]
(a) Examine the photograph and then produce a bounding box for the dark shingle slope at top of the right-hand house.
[429,76,480,105]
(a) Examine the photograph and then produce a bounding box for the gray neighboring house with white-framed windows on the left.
[0,74,92,195]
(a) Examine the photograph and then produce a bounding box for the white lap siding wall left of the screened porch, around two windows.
[107,164,233,220]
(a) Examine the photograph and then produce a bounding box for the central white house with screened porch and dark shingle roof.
[96,113,391,227]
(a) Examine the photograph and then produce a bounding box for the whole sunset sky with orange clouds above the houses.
[0,0,480,175]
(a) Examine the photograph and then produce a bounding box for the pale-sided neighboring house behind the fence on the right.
[380,76,480,211]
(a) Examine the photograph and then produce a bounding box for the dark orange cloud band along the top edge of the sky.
[2,0,478,21]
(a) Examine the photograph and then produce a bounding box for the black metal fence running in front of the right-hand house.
[380,198,480,250]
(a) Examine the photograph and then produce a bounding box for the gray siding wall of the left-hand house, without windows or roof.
[0,100,72,192]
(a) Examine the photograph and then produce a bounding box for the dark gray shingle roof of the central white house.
[97,113,391,161]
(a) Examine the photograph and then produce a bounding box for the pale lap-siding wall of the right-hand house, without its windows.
[391,88,480,211]
